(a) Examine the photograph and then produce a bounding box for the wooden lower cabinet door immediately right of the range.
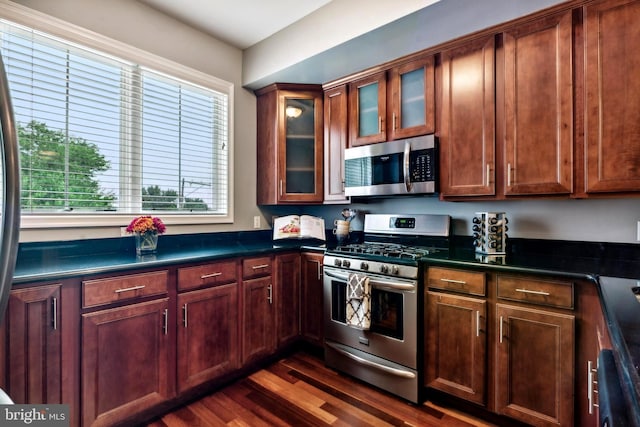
[425,292,487,405]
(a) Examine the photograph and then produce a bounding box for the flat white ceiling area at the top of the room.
[139,0,331,49]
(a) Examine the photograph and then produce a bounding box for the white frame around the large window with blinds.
[0,3,235,229]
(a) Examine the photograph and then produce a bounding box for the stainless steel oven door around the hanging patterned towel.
[323,266,418,369]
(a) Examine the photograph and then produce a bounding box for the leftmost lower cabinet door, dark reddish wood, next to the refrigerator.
[7,285,63,403]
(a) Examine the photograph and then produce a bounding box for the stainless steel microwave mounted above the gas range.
[344,135,437,196]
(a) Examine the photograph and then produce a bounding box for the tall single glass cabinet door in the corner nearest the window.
[280,94,323,201]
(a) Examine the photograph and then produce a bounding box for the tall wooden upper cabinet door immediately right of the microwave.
[439,36,496,197]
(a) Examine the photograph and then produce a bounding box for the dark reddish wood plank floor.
[148,352,493,427]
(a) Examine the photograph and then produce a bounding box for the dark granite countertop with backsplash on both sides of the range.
[8,230,640,425]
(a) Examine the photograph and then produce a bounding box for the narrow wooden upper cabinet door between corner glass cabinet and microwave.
[324,84,349,203]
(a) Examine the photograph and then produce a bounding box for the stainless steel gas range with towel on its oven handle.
[323,214,450,403]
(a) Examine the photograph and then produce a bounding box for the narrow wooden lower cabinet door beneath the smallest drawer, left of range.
[242,276,276,364]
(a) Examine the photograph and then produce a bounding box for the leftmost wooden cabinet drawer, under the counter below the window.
[82,270,168,308]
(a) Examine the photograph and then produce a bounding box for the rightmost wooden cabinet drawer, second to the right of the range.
[496,275,573,309]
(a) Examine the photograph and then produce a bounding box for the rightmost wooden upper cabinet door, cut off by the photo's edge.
[583,0,640,193]
